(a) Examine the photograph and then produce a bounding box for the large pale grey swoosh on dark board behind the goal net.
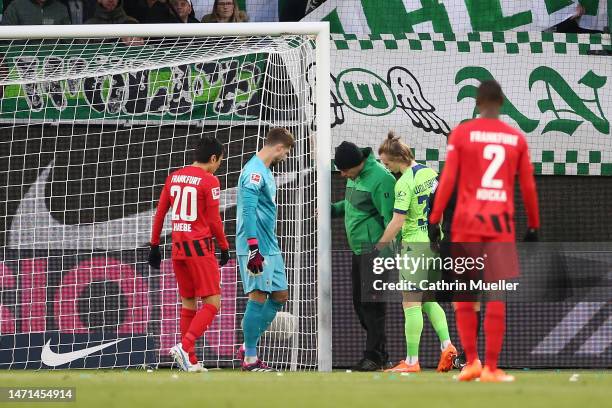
[8,162,311,250]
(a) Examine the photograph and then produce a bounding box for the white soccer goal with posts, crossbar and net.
[0,23,332,371]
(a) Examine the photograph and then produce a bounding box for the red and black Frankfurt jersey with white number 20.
[151,166,229,259]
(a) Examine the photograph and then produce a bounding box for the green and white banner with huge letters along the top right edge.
[303,0,609,34]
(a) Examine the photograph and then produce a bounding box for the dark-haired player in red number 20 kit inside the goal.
[149,137,229,371]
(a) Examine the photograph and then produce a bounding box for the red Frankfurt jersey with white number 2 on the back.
[429,118,540,237]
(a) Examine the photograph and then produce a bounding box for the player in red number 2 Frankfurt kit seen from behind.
[429,81,540,382]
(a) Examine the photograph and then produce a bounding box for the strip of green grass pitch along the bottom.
[0,369,612,408]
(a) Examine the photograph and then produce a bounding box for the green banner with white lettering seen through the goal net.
[0,44,267,123]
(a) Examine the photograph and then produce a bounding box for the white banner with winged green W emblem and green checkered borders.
[331,32,612,176]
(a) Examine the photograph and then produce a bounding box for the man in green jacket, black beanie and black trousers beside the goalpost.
[331,141,395,371]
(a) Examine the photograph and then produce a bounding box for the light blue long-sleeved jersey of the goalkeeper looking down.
[236,155,281,256]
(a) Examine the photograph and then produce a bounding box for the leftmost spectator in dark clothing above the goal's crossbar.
[2,0,71,25]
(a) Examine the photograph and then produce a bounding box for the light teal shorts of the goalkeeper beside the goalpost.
[237,254,288,293]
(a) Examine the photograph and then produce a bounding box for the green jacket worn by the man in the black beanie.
[331,147,395,255]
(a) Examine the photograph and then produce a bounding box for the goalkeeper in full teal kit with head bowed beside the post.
[236,128,294,371]
